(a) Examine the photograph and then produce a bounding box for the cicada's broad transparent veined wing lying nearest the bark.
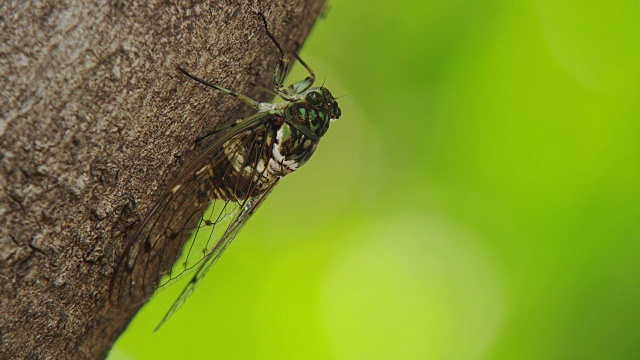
[110,113,277,308]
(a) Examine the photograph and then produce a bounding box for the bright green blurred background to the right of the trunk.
[111,0,640,359]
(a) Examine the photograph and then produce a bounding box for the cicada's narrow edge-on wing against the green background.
[156,181,277,330]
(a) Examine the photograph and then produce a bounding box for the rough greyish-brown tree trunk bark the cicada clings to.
[0,0,323,358]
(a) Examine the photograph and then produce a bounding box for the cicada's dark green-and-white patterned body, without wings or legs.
[197,102,330,201]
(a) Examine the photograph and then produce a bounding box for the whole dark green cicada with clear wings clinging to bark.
[110,14,341,327]
